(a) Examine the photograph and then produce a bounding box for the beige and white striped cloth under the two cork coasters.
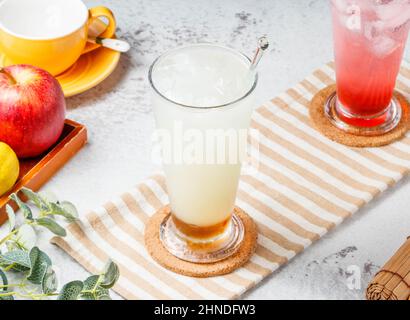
[52,62,410,299]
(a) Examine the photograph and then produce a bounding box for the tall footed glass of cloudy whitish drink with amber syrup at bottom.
[150,44,257,262]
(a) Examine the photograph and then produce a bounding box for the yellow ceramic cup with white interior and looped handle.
[0,0,116,75]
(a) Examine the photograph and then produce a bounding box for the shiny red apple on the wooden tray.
[0,64,65,158]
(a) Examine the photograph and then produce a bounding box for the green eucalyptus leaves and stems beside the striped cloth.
[0,188,119,300]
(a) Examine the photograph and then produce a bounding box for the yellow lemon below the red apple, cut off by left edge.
[0,142,20,196]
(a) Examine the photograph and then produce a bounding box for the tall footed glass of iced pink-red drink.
[326,0,410,135]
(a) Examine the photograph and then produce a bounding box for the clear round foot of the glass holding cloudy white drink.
[159,214,245,263]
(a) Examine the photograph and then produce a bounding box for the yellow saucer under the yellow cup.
[0,47,121,97]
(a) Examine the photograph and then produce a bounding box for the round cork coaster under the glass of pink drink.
[309,85,410,148]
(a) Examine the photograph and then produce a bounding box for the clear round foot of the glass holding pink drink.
[325,92,402,136]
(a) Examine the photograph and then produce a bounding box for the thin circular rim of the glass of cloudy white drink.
[148,42,259,110]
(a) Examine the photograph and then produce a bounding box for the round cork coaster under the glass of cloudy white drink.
[144,206,258,278]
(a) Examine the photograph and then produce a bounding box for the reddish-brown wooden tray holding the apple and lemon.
[0,120,87,225]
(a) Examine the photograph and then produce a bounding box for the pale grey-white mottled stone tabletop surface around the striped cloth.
[0,0,410,299]
